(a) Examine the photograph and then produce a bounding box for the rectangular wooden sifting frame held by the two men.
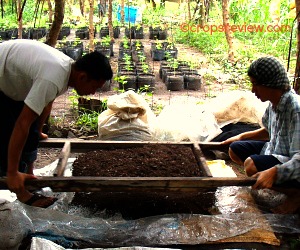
[0,139,255,192]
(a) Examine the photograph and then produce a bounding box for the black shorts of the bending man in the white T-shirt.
[0,91,39,176]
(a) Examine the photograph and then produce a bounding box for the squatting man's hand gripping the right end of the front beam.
[252,167,277,189]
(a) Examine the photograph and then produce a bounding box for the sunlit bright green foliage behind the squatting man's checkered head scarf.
[174,0,297,88]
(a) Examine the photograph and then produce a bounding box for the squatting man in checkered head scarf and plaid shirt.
[222,57,300,213]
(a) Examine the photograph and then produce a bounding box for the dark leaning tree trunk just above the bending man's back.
[46,0,65,47]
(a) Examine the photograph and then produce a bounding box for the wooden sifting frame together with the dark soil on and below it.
[0,139,254,219]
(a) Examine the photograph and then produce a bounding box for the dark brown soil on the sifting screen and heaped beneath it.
[72,144,215,219]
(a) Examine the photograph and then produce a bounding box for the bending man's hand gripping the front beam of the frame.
[7,171,37,195]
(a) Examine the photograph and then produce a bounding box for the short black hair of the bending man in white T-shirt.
[75,51,113,80]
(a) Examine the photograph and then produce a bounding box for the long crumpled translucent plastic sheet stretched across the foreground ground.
[1,189,300,248]
